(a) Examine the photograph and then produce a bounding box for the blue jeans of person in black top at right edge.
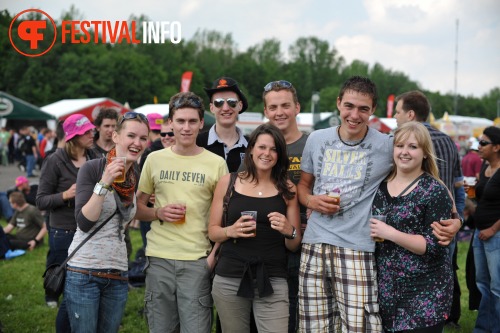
[472,229,500,333]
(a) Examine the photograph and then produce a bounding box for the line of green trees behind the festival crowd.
[0,6,500,119]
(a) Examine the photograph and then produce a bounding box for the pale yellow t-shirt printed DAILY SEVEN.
[138,148,228,260]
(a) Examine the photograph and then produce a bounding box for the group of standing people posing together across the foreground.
[30,76,500,333]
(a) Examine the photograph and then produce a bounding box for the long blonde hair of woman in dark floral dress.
[387,121,439,180]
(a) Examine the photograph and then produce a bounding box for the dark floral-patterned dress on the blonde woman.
[372,174,453,332]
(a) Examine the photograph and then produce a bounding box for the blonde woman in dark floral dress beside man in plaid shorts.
[370,122,453,333]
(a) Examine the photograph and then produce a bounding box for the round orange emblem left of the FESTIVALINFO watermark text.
[9,9,57,57]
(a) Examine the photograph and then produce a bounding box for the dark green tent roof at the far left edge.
[0,91,56,121]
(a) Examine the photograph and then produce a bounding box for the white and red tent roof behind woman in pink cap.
[42,97,130,121]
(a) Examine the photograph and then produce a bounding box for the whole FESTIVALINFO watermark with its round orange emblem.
[9,9,182,57]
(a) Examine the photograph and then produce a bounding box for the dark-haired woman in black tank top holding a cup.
[208,124,301,333]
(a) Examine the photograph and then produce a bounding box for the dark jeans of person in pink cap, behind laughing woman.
[45,227,75,333]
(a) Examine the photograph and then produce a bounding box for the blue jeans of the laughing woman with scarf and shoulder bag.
[64,267,128,333]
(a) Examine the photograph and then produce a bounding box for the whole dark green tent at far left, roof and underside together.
[0,91,54,127]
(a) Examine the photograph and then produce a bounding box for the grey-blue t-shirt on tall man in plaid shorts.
[301,127,393,252]
